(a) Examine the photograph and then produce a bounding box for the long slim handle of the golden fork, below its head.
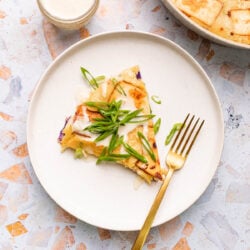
[131,168,174,250]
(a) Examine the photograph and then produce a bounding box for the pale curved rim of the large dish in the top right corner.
[162,0,250,49]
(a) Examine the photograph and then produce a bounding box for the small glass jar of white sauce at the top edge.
[37,0,99,29]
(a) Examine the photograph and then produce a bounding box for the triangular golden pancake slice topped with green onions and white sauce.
[59,66,163,183]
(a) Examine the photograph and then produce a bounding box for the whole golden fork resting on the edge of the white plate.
[132,114,204,250]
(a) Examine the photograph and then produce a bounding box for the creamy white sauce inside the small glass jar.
[40,0,95,20]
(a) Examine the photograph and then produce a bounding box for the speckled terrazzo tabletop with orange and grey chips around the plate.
[0,0,250,250]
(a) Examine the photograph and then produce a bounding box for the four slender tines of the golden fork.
[170,114,205,157]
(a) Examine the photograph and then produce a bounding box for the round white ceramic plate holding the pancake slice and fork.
[27,31,224,230]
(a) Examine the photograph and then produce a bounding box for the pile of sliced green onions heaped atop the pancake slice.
[84,100,155,163]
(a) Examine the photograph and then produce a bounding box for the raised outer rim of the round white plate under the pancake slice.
[26,30,225,231]
